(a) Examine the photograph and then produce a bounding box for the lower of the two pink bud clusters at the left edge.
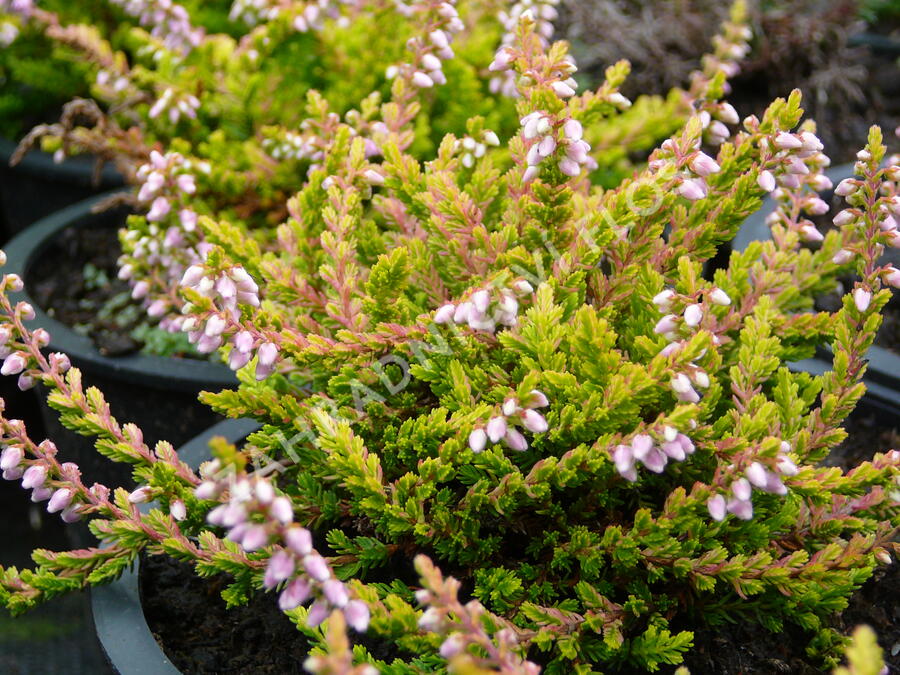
[0,440,82,523]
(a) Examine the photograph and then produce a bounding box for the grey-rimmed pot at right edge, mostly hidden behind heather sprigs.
[732,164,900,416]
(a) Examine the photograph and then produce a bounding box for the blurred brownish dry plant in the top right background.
[558,0,900,162]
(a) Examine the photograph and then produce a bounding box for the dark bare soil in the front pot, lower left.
[141,556,309,675]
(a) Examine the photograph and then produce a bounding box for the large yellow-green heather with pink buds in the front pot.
[0,5,900,674]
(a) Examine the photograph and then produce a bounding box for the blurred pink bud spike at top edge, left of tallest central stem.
[387,0,465,89]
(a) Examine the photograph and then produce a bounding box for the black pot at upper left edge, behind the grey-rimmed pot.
[0,138,124,242]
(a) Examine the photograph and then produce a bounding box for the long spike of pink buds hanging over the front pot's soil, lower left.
[195,470,369,632]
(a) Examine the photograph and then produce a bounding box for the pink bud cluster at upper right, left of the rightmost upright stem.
[744,125,832,242]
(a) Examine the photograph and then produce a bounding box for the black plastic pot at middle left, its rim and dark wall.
[4,195,237,485]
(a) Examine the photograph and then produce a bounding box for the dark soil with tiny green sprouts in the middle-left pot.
[27,222,198,358]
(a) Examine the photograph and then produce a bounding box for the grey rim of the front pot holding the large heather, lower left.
[91,420,259,675]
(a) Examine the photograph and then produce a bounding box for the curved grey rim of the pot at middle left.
[2,190,238,391]
